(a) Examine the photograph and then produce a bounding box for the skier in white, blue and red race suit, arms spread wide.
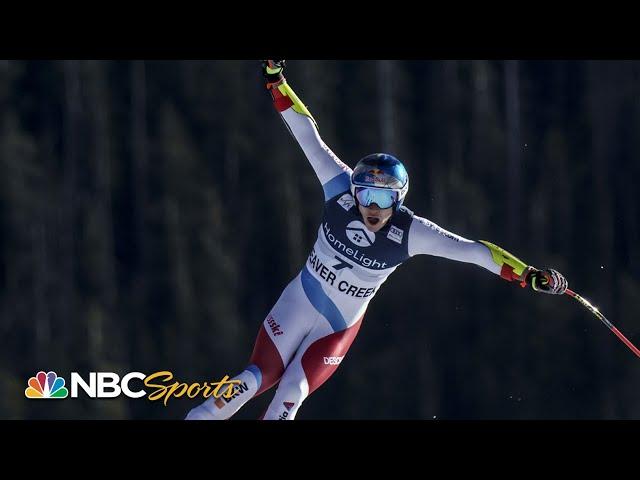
[186,60,567,420]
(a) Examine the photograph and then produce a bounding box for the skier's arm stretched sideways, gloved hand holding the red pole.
[409,216,567,294]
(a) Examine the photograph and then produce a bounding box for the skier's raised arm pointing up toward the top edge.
[262,60,351,200]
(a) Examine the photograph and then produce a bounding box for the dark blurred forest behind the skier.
[0,60,640,419]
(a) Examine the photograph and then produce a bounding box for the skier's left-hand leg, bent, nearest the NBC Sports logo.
[186,275,317,420]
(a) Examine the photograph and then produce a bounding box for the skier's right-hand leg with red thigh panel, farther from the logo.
[263,318,362,420]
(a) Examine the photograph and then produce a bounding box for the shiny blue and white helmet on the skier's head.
[351,153,409,210]
